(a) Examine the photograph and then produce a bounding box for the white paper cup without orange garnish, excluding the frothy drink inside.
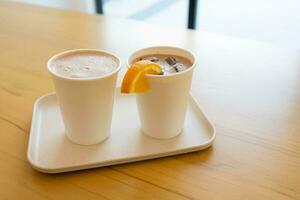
[47,49,121,145]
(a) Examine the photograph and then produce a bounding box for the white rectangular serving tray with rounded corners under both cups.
[27,92,215,173]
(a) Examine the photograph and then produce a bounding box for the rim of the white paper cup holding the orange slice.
[126,46,197,78]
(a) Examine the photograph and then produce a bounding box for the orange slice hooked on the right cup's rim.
[121,60,162,93]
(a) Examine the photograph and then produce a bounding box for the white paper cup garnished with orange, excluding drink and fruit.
[128,46,196,139]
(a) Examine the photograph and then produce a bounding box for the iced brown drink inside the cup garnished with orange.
[135,54,193,75]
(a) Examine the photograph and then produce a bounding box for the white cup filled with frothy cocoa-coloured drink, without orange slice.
[47,49,120,145]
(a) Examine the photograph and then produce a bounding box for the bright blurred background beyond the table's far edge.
[13,0,300,49]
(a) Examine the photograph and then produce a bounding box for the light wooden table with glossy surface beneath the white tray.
[0,1,300,200]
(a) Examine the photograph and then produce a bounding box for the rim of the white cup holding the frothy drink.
[47,49,121,81]
